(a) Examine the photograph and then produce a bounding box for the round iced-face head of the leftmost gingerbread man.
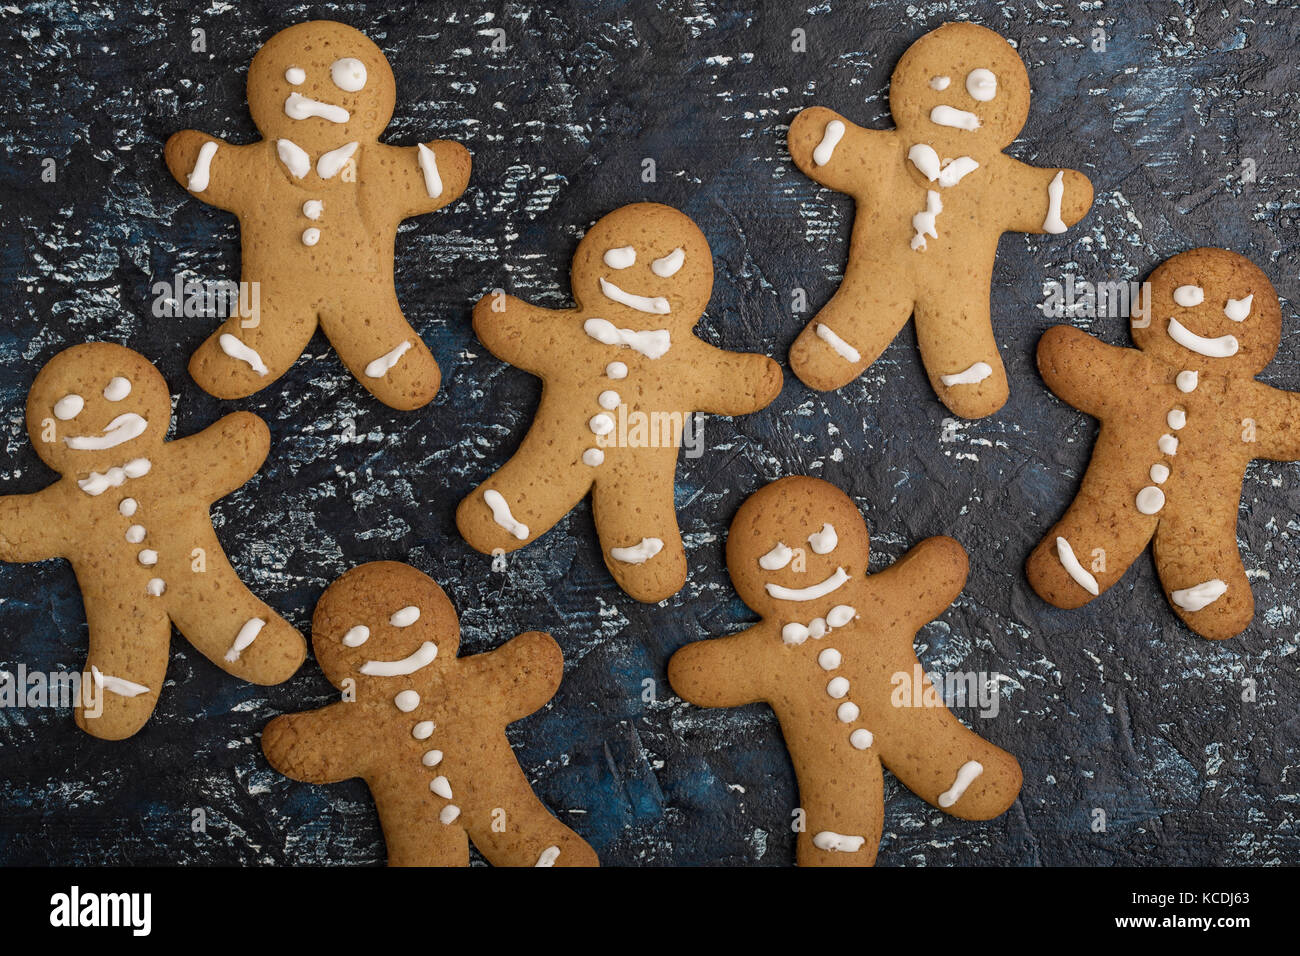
[27,342,172,475]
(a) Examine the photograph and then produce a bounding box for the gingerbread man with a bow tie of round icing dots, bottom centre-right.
[668,477,1021,866]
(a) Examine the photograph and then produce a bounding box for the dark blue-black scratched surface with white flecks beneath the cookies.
[0,0,1300,866]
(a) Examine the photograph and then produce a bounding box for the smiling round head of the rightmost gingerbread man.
[1132,248,1282,377]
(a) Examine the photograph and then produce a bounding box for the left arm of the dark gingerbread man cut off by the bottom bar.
[261,701,372,783]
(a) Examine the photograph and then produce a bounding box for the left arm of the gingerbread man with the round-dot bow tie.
[668,623,781,708]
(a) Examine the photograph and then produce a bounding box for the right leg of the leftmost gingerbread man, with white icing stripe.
[163,564,307,684]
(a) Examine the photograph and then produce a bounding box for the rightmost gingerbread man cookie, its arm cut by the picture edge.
[1027,248,1300,640]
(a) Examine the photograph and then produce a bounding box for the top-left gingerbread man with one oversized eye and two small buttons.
[166,21,469,408]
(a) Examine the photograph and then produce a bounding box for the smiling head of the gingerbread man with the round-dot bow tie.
[727,476,870,623]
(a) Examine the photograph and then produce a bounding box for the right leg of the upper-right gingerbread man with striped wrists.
[917,280,1009,419]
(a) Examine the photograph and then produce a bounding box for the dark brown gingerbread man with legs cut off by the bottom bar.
[261,561,598,866]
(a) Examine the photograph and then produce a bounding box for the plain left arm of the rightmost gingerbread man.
[1039,325,1147,419]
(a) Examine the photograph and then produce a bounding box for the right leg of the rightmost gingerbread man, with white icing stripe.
[1152,494,1255,640]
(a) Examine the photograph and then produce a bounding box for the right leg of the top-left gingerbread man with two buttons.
[321,281,442,411]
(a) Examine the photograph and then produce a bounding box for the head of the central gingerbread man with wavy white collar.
[572,203,714,333]
